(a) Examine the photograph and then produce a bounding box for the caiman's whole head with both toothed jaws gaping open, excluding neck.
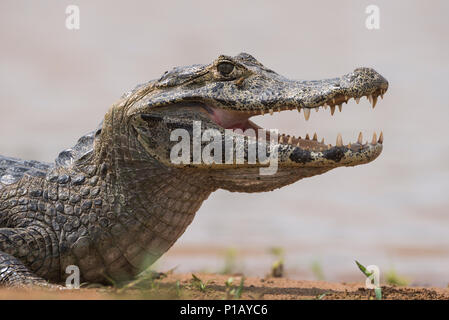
[100,53,388,192]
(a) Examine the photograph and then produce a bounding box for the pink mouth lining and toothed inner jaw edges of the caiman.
[204,88,387,152]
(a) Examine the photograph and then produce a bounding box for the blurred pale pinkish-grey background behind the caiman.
[0,0,449,287]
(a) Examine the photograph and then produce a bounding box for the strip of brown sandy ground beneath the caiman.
[0,273,449,300]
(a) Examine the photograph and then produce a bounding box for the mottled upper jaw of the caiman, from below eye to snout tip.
[215,68,388,115]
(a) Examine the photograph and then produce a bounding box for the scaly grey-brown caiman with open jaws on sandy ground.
[0,53,388,286]
